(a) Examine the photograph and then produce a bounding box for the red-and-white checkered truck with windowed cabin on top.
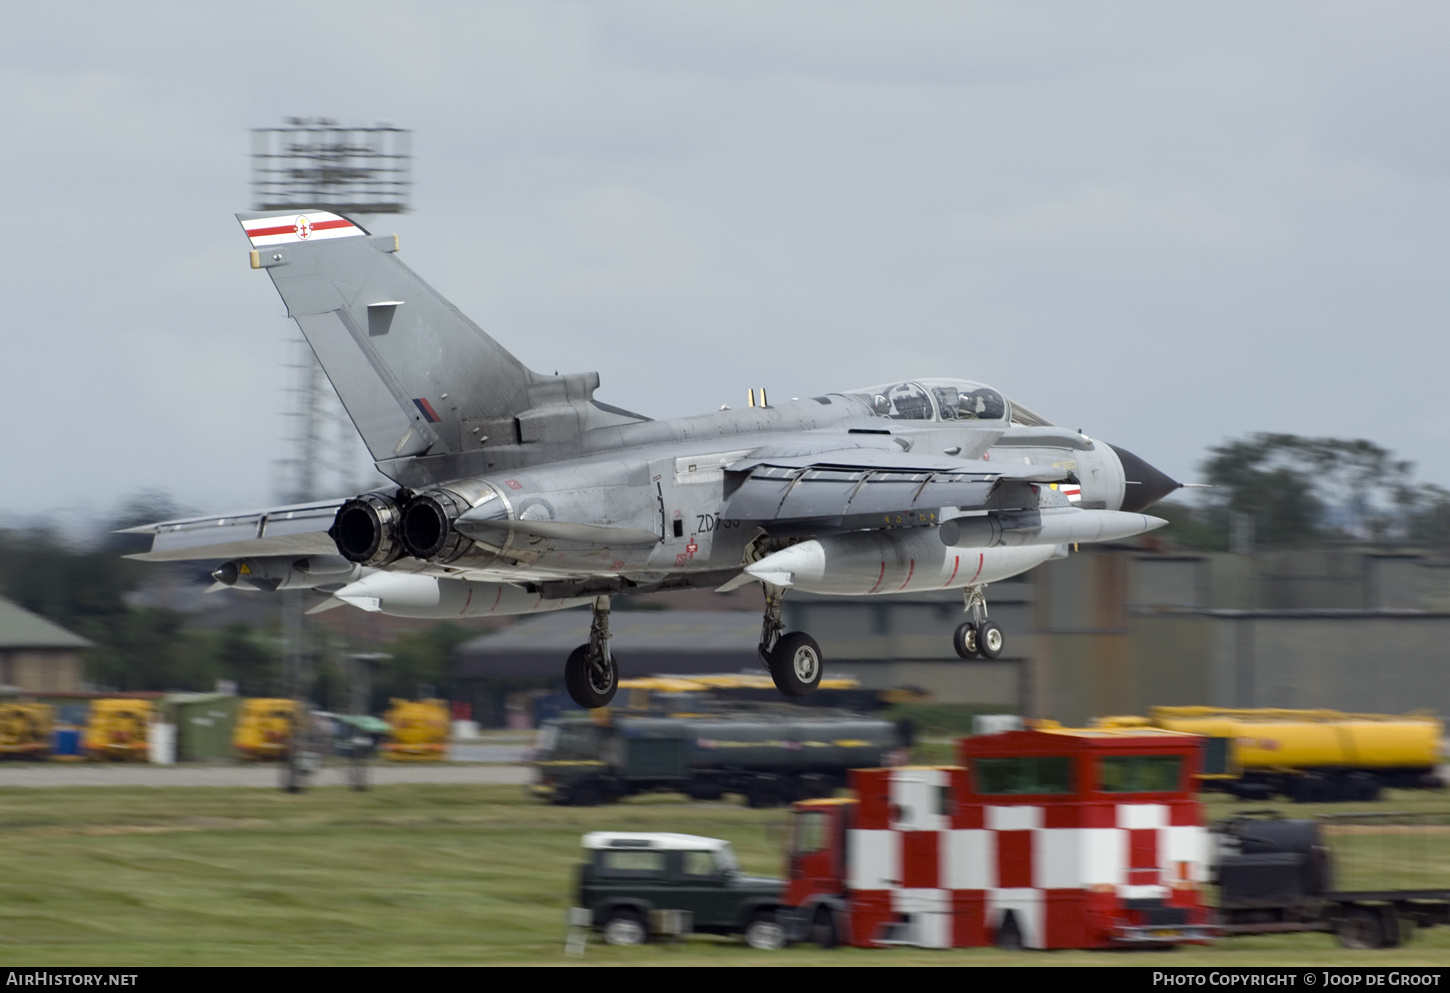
[780,728,1214,948]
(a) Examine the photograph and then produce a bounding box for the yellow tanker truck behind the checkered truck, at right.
[1098,706,1444,803]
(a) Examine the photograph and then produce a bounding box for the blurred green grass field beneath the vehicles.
[0,786,1450,967]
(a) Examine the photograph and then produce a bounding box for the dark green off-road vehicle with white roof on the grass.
[570,831,786,950]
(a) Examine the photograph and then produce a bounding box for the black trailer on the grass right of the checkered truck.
[1211,810,1450,948]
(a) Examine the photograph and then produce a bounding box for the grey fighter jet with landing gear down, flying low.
[133,210,1179,707]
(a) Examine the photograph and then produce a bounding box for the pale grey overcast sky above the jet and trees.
[0,0,1450,530]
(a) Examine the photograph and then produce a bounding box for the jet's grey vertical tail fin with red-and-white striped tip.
[236,210,599,478]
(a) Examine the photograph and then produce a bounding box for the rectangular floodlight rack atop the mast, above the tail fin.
[252,117,413,216]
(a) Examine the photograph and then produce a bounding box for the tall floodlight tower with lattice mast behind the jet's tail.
[251,117,412,792]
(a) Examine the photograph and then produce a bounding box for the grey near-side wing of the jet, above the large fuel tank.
[724,448,1069,533]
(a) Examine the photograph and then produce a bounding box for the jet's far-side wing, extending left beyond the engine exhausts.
[120,500,342,562]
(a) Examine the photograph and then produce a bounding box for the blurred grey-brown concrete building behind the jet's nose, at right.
[1028,547,1450,723]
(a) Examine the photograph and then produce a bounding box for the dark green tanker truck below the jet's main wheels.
[531,707,909,807]
